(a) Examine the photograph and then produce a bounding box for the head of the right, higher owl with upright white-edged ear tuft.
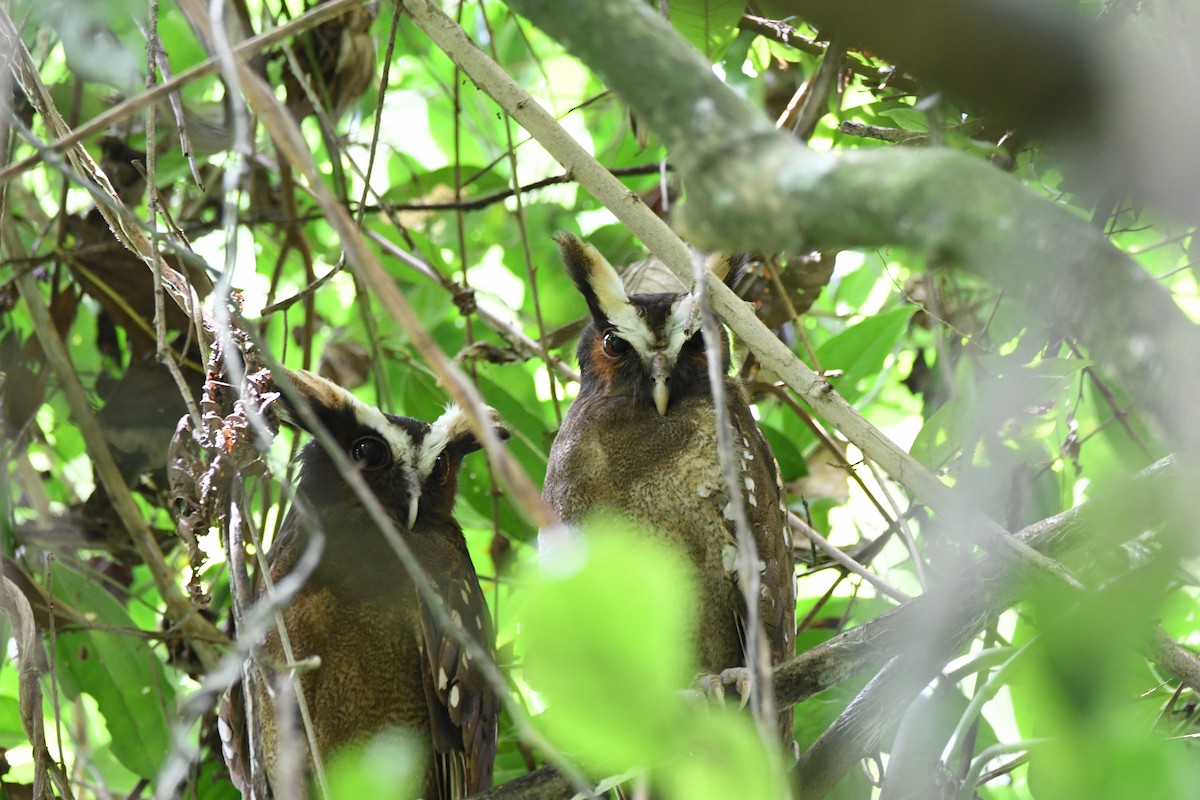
[556,233,733,415]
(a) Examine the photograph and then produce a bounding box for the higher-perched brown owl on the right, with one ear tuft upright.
[544,234,796,742]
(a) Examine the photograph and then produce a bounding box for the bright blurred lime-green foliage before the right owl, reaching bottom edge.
[522,518,786,800]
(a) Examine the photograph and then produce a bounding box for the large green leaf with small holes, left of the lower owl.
[52,561,175,778]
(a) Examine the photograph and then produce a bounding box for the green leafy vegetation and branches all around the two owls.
[0,0,1200,800]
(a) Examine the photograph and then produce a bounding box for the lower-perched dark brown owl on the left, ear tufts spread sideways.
[226,371,506,798]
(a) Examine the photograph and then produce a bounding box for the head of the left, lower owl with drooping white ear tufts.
[283,369,509,530]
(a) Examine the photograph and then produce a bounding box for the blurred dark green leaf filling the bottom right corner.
[1010,559,1200,800]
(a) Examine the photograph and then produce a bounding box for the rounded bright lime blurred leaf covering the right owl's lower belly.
[521,519,695,775]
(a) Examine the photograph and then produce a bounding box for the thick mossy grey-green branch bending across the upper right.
[509,0,1200,470]
